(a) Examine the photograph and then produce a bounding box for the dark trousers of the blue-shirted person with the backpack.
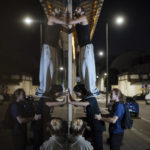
[110,133,124,150]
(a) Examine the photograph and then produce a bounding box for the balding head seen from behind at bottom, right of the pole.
[71,119,87,136]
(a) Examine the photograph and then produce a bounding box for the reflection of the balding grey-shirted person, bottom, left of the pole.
[40,118,66,150]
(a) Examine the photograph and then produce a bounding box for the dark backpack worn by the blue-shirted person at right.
[121,104,133,129]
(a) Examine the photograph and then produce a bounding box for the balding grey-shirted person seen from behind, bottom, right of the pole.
[69,119,93,150]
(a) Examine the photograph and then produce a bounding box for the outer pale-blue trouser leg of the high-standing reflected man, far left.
[39,44,50,93]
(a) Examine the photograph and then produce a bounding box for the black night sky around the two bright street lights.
[0,0,150,76]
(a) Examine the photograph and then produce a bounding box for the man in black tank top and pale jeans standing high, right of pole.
[69,6,100,96]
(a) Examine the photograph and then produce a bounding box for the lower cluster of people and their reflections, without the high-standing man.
[10,84,125,150]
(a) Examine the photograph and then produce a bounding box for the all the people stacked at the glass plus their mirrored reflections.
[10,6,125,150]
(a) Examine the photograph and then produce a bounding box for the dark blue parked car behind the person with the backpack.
[108,97,139,117]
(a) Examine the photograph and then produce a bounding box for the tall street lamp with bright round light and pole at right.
[105,16,124,106]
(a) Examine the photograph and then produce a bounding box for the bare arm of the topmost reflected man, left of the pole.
[47,16,66,25]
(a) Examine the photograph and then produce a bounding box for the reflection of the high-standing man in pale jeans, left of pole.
[35,8,66,97]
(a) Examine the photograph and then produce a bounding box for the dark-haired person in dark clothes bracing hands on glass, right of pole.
[68,84,106,150]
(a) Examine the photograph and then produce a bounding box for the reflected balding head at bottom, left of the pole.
[48,118,63,136]
